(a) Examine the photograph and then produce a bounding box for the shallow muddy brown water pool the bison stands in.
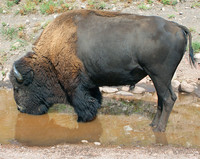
[0,90,200,148]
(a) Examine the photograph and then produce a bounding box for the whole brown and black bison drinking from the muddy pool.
[10,10,195,131]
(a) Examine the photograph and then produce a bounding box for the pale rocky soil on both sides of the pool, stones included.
[0,0,200,159]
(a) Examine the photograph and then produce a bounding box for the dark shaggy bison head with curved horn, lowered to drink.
[10,53,66,115]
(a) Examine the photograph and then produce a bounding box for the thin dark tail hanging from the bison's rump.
[177,24,196,67]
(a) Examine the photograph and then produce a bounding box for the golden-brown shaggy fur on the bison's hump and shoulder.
[33,10,145,94]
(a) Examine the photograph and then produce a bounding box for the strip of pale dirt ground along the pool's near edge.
[0,144,200,159]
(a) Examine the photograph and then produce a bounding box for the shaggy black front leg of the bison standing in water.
[72,85,101,122]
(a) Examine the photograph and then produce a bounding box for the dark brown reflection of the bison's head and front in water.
[15,113,102,145]
